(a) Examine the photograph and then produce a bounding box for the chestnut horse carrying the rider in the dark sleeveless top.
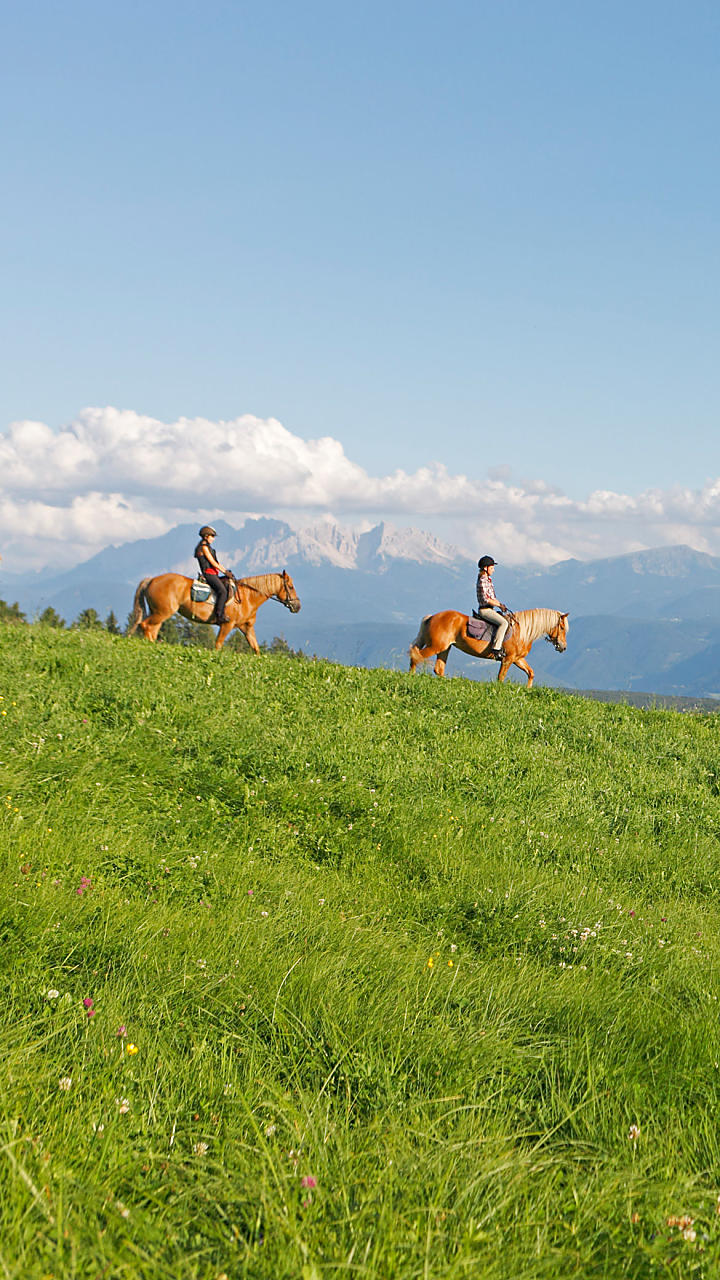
[128,570,300,653]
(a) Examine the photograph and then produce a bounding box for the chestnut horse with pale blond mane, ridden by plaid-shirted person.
[410,609,570,689]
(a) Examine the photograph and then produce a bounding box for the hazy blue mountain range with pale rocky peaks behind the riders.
[0,518,720,698]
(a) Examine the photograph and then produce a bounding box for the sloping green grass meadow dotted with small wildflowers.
[0,625,720,1280]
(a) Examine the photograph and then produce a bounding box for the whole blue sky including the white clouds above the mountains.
[0,0,720,570]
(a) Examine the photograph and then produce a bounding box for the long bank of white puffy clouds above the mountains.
[0,407,720,570]
